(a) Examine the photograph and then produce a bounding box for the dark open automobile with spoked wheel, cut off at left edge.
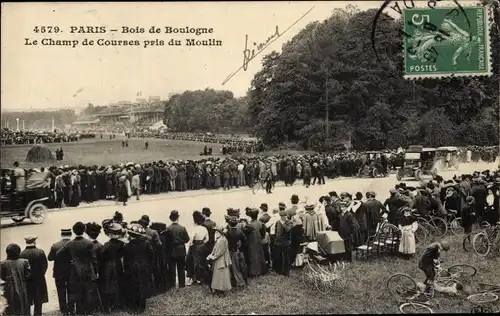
[0,169,54,224]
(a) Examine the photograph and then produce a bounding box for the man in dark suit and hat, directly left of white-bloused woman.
[164,210,189,288]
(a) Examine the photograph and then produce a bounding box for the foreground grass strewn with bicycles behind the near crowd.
[47,233,500,316]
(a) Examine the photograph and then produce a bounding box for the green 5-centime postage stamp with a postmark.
[403,6,492,79]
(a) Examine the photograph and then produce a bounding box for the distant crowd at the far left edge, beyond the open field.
[0,128,95,145]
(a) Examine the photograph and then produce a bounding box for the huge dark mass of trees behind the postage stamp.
[247,5,500,149]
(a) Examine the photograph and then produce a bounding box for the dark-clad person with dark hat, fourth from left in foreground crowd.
[56,222,98,315]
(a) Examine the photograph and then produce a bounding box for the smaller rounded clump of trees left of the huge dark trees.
[165,89,249,133]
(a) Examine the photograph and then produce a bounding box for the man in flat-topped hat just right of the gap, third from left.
[48,229,74,315]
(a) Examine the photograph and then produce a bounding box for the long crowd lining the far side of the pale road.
[1,144,498,207]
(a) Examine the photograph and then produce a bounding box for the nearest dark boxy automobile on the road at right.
[396,146,437,181]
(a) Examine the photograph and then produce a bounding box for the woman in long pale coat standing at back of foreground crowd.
[207,227,232,294]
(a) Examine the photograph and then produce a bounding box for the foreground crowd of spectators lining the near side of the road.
[0,170,500,315]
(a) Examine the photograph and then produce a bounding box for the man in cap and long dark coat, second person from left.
[19,236,49,316]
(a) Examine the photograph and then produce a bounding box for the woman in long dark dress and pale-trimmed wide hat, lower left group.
[123,223,155,312]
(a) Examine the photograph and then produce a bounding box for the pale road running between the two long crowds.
[0,163,500,313]
